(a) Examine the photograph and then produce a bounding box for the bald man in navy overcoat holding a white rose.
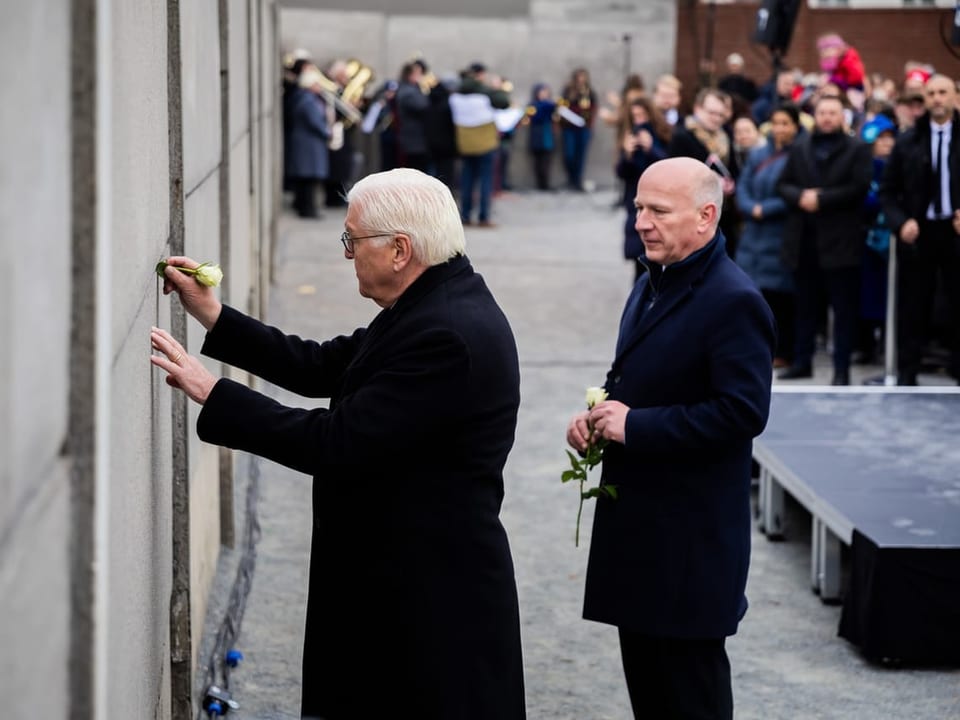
[567,158,775,718]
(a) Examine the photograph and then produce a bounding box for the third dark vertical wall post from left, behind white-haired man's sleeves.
[217,0,236,548]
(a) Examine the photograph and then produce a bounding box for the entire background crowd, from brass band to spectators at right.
[284,39,960,385]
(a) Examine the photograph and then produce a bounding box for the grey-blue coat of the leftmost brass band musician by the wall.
[283,88,330,180]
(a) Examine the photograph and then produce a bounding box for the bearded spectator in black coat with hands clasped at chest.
[777,95,873,385]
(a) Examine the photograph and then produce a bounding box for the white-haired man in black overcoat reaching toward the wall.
[152,169,525,720]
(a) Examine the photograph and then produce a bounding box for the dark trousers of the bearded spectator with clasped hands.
[793,236,860,373]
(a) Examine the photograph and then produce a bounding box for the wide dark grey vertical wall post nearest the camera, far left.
[66,0,97,720]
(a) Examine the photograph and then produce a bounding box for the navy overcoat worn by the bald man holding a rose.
[583,232,774,638]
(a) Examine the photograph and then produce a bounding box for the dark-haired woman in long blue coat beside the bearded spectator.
[737,103,801,367]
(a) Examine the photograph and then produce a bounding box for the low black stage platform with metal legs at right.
[754,387,960,664]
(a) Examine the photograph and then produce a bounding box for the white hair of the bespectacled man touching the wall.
[347,168,467,266]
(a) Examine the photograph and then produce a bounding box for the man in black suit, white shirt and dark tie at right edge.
[880,75,960,385]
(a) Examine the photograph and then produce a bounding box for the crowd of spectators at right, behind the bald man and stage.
[610,39,960,385]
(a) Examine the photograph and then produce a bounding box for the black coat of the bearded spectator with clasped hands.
[777,133,873,270]
